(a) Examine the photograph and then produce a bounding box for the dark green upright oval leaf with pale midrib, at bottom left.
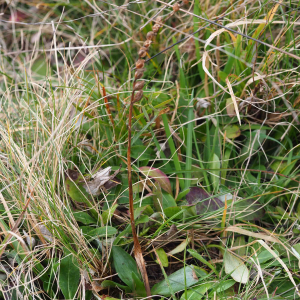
[59,254,80,299]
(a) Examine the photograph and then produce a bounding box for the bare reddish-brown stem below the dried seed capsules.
[127,80,151,299]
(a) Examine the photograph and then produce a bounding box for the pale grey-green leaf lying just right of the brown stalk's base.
[151,265,198,297]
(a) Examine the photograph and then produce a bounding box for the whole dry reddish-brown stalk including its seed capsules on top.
[127,0,189,299]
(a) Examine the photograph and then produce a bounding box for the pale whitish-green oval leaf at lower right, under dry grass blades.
[223,251,249,284]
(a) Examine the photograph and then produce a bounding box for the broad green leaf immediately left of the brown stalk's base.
[112,246,141,291]
